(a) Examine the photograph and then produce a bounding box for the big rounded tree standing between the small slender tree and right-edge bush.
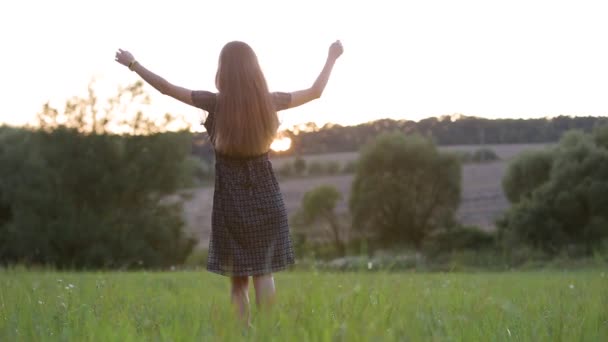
[349,133,461,248]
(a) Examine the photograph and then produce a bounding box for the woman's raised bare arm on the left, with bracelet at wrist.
[115,49,194,106]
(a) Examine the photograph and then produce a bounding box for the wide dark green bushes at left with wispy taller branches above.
[0,84,197,268]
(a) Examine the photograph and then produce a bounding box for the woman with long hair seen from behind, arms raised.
[116,41,343,322]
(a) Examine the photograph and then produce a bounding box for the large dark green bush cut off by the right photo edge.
[498,128,608,254]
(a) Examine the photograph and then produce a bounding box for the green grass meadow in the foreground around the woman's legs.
[0,270,608,341]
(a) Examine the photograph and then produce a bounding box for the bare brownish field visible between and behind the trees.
[185,144,548,246]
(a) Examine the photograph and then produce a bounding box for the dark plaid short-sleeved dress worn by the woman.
[192,91,294,276]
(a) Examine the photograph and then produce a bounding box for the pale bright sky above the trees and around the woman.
[0,0,608,132]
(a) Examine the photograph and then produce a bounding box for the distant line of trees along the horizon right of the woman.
[262,116,608,155]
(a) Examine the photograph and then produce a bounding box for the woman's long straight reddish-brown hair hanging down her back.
[214,41,279,156]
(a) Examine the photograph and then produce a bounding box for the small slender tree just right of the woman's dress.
[300,185,346,256]
